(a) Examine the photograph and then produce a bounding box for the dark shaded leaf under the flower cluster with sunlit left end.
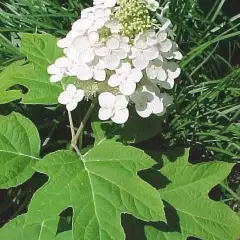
[92,109,163,144]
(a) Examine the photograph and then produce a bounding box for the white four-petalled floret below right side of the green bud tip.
[130,33,159,70]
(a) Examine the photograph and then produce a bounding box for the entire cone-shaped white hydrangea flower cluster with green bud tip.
[48,0,182,124]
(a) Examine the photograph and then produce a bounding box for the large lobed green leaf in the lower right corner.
[147,152,240,240]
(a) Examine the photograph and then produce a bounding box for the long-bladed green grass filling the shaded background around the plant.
[0,0,240,236]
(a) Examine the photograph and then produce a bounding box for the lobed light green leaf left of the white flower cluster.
[0,33,62,104]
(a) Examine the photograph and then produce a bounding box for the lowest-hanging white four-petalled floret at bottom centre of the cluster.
[98,92,129,124]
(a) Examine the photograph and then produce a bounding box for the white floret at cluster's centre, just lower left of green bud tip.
[104,34,130,70]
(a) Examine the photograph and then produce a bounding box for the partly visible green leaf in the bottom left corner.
[0,215,59,240]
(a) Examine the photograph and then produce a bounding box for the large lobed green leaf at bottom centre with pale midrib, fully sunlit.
[27,141,165,240]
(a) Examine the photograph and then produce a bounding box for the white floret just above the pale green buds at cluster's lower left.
[77,58,106,82]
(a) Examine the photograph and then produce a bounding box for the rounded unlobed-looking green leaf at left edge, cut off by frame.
[0,113,40,188]
